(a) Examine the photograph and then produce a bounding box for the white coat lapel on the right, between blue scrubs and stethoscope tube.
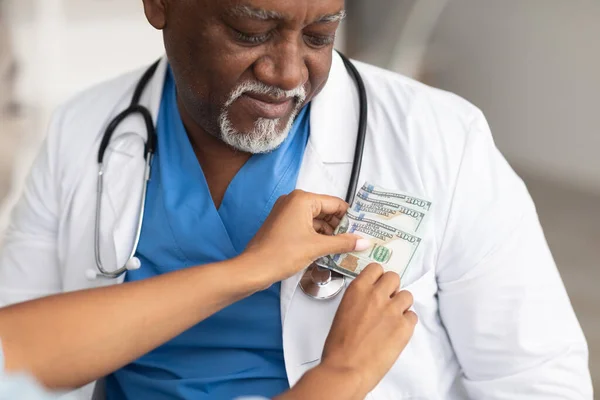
[281,53,359,372]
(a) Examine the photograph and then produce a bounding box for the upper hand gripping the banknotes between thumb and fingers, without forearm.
[243,190,369,284]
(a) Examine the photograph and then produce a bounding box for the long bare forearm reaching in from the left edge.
[0,253,268,388]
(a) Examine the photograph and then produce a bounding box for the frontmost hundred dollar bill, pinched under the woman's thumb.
[324,211,421,277]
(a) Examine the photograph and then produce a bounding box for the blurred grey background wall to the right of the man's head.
[347,0,600,193]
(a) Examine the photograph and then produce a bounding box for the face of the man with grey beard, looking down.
[144,0,344,153]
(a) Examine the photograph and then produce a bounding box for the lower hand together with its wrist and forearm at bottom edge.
[276,264,417,400]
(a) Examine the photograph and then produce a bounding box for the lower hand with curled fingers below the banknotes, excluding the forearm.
[321,264,417,395]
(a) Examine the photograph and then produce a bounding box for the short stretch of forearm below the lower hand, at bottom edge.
[274,364,369,400]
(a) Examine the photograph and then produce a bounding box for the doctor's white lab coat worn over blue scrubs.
[0,55,592,400]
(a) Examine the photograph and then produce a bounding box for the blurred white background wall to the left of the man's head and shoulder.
[0,0,164,234]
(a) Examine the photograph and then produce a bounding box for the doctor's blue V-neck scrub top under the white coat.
[107,71,309,400]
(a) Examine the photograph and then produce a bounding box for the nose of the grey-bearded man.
[254,38,308,90]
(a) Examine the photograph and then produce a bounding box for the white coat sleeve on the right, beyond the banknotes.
[437,110,592,400]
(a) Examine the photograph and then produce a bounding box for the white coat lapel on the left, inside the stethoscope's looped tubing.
[103,57,167,268]
